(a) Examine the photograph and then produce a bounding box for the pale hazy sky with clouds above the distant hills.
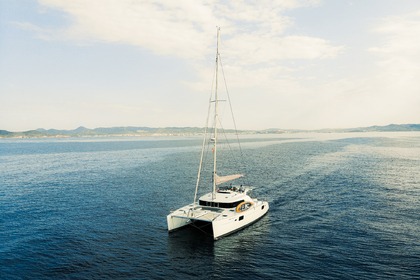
[0,0,420,131]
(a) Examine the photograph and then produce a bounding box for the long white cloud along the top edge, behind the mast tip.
[32,0,338,63]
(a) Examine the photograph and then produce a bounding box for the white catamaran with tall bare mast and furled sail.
[167,27,269,240]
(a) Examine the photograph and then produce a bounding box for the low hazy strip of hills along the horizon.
[0,124,420,138]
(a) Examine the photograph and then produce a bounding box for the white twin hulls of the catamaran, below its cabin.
[167,200,269,240]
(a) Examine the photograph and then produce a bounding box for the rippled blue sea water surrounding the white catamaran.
[0,132,420,279]
